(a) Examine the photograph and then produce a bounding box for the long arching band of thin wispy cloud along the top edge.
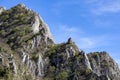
[52,0,120,15]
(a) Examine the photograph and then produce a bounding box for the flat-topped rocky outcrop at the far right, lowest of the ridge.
[88,52,120,80]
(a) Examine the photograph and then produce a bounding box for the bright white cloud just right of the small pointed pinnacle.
[76,35,109,50]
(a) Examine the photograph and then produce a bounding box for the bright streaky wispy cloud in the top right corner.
[88,0,120,15]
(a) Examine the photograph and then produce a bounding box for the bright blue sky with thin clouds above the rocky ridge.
[0,0,120,64]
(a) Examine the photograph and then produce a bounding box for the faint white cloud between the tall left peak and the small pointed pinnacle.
[53,24,85,43]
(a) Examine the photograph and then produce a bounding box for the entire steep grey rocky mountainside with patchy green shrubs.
[0,4,120,80]
